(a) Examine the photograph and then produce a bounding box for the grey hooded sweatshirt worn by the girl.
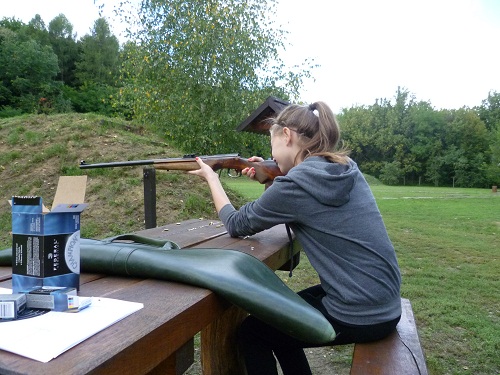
[219,156,401,325]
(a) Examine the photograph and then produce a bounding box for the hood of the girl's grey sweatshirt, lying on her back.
[286,156,360,207]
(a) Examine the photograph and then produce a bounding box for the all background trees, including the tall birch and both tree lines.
[0,0,500,188]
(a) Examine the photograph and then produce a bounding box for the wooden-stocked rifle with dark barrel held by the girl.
[80,154,283,184]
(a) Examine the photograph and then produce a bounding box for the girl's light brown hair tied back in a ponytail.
[270,102,349,164]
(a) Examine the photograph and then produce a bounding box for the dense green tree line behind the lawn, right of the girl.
[338,89,500,187]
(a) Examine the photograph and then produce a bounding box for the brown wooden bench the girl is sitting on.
[351,298,427,375]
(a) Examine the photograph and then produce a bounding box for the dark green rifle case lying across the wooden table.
[0,235,335,345]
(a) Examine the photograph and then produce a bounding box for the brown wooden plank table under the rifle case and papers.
[0,220,300,375]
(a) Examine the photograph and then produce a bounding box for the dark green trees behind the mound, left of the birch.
[0,14,120,117]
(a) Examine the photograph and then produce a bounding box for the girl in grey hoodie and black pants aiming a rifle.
[189,102,401,375]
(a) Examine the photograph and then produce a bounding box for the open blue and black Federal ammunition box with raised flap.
[11,176,87,293]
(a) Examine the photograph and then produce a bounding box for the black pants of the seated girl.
[238,285,399,375]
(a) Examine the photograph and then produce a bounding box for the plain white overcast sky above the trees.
[0,0,500,111]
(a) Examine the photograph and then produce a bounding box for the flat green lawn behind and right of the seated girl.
[224,178,500,375]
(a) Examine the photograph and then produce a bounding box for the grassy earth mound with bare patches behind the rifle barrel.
[0,114,246,248]
